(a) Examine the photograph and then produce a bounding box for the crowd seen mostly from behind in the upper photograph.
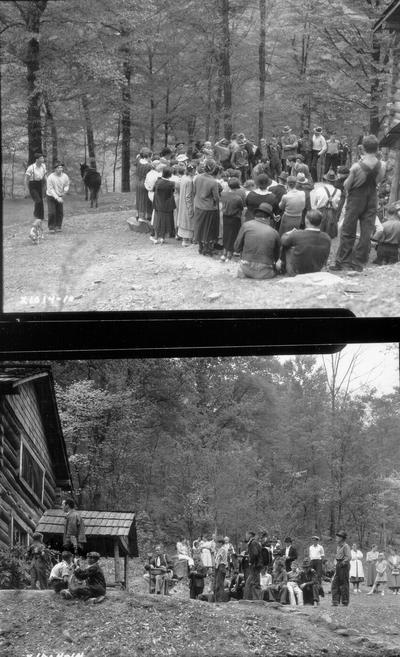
[136,126,400,279]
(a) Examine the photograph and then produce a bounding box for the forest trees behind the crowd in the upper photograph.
[0,0,392,197]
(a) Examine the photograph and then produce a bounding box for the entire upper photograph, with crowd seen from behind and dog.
[0,0,400,318]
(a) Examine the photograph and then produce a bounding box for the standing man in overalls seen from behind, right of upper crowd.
[330,135,386,271]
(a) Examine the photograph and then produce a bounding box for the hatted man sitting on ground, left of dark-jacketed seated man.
[234,203,281,279]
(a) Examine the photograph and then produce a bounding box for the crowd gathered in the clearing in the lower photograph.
[141,531,400,607]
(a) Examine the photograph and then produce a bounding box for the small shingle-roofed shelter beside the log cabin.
[36,509,139,557]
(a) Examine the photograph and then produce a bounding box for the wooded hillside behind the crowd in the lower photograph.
[52,354,400,549]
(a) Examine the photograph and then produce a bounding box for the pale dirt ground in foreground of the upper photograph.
[3,193,400,317]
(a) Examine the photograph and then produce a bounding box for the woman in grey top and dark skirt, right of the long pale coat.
[193,160,219,256]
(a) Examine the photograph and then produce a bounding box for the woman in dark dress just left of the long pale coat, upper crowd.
[150,167,176,244]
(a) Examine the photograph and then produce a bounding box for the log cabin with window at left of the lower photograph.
[0,365,72,548]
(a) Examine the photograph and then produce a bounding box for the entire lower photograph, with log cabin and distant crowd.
[0,344,400,657]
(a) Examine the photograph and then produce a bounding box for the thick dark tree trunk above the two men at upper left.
[15,0,47,162]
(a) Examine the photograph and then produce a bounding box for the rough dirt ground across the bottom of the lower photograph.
[0,574,400,657]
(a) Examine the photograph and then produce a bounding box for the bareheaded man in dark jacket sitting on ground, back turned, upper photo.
[278,210,331,276]
